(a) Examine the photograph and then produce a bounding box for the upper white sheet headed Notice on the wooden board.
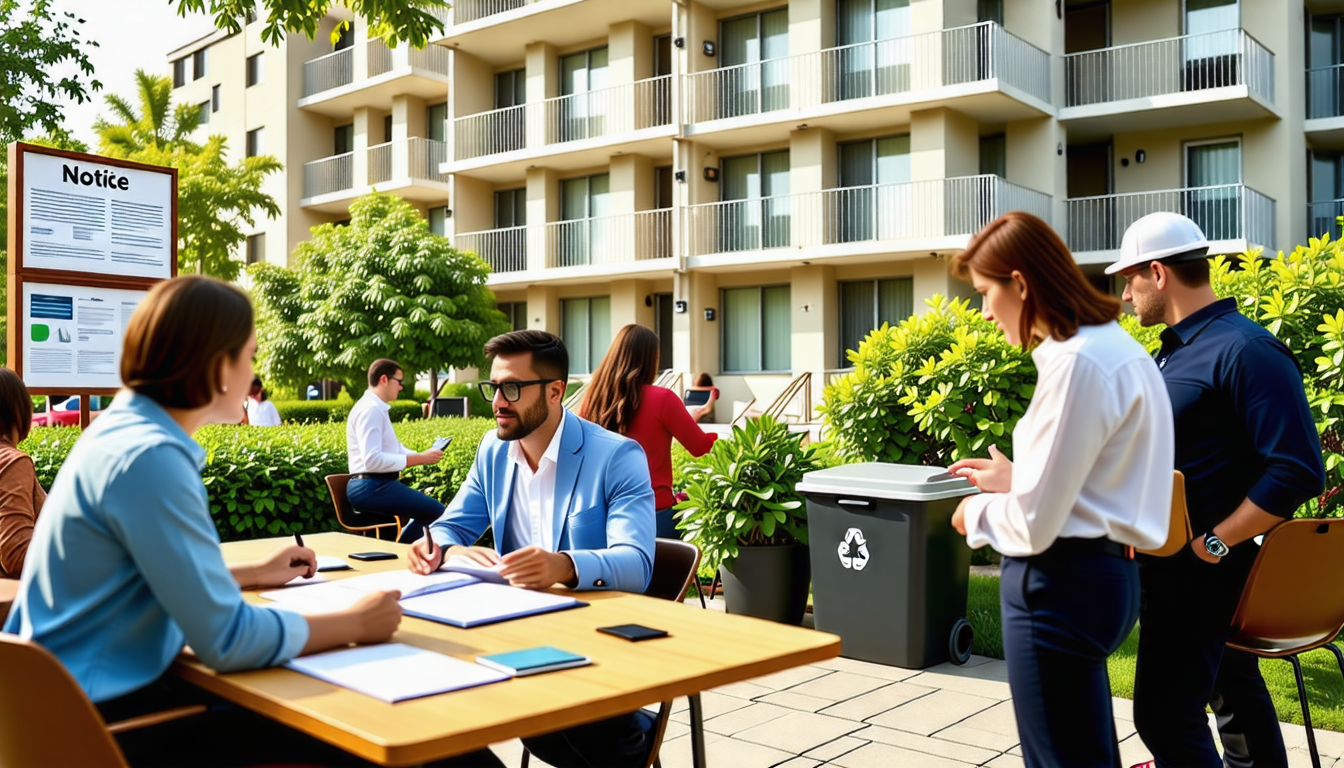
[20,152,176,281]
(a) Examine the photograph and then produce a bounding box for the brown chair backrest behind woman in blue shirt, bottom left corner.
[0,635,126,768]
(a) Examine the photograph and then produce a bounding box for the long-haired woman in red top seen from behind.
[578,324,718,538]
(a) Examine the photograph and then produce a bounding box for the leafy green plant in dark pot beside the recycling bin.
[676,416,823,624]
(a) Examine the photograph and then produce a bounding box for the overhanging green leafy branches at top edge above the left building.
[168,0,449,48]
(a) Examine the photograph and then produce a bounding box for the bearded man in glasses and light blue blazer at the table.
[409,330,655,768]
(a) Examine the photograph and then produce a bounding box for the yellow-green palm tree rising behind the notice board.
[94,70,282,280]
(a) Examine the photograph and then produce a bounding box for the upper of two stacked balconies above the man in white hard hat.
[1059,30,1277,133]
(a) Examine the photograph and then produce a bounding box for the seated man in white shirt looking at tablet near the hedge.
[345,358,444,542]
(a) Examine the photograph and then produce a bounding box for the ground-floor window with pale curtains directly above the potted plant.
[719,285,793,374]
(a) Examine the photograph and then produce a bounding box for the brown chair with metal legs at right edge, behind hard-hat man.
[1227,518,1344,768]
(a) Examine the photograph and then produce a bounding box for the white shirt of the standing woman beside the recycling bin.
[965,321,1175,557]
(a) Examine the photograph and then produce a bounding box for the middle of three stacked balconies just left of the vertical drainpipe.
[454,75,672,178]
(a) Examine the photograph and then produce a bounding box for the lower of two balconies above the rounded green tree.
[300,137,448,213]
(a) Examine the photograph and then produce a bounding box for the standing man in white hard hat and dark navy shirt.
[1106,213,1325,768]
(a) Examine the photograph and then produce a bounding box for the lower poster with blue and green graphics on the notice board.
[23,282,146,389]
